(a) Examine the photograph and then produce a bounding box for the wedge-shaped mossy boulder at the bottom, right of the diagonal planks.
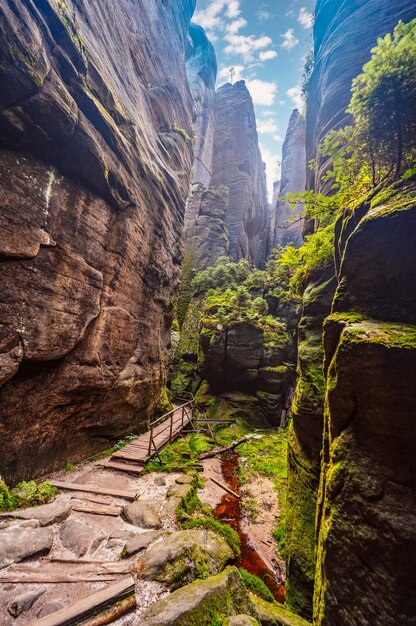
[141,567,257,626]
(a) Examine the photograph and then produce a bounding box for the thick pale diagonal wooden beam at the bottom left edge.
[28,576,134,626]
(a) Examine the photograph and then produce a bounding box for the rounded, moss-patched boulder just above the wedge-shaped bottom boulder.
[140,529,233,589]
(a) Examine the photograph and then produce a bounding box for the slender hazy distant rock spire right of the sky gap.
[272,109,306,247]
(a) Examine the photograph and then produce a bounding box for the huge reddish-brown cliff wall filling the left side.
[0,0,195,481]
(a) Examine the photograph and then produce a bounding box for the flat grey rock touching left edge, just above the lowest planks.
[0,526,53,569]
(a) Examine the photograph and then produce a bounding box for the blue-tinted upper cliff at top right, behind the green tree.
[306,0,415,193]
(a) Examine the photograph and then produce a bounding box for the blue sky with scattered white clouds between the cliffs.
[193,0,315,199]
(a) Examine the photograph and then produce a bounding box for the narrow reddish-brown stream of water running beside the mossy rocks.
[215,453,285,604]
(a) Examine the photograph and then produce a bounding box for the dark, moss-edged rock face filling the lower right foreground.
[315,183,416,626]
